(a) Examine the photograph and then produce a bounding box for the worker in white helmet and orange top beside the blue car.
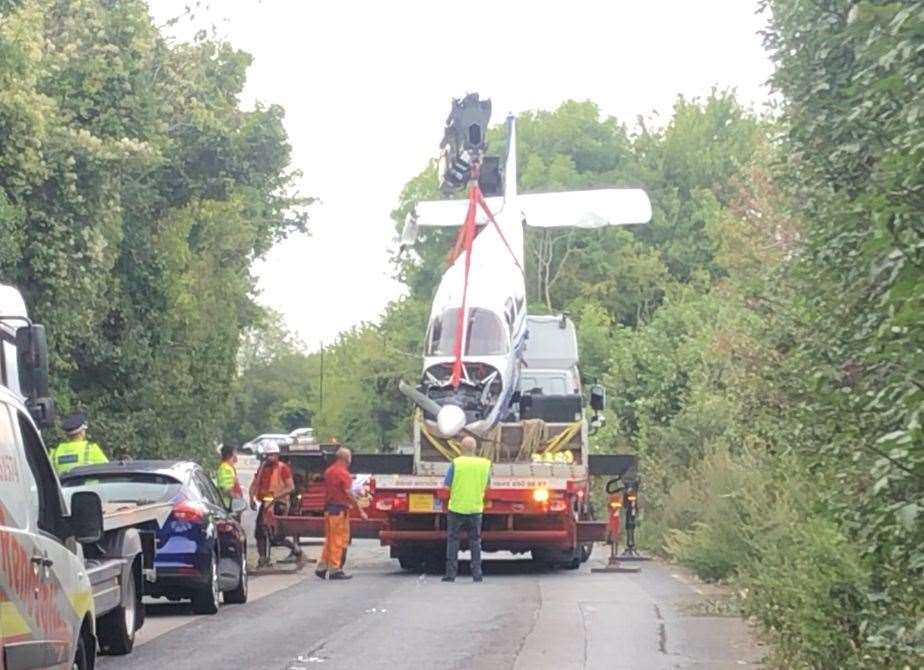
[250,443,302,568]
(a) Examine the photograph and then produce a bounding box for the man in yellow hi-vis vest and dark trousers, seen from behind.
[443,435,491,582]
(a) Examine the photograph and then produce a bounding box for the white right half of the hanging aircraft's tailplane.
[516,188,651,228]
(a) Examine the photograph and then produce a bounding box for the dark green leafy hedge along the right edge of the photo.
[767,0,924,667]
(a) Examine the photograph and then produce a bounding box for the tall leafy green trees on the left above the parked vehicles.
[0,0,305,456]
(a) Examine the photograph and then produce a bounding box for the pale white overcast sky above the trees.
[150,0,771,349]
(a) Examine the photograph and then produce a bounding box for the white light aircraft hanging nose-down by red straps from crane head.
[400,93,651,437]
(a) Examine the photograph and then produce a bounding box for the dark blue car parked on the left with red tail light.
[61,461,247,614]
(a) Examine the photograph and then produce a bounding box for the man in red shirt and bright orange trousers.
[314,447,368,579]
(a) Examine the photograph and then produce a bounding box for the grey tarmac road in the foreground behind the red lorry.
[98,540,762,670]
